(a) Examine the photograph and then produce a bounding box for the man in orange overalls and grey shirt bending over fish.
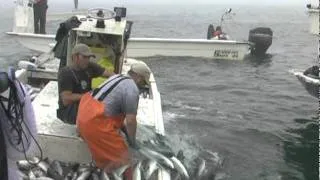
[76,62,151,179]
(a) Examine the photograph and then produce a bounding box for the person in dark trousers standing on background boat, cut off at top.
[33,0,48,34]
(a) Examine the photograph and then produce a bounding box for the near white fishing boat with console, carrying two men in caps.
[9,8,170,180]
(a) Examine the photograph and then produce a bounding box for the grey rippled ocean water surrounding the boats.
[0,2,319,180]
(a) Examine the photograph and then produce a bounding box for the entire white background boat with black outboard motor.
[7,0,272,60]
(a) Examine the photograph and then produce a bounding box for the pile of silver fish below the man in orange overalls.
[17,139,224,180]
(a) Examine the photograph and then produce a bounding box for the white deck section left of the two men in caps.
[32,81,91,163]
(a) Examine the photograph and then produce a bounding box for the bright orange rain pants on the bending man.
[76,92,129,171]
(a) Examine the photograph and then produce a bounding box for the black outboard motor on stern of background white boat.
[249,27,273,56]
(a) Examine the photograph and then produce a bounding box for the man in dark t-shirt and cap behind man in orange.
[57,44,114,124]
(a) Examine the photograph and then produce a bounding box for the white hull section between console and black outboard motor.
[127,38,250,60]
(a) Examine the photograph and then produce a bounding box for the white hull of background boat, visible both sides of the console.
[7,32,252,60]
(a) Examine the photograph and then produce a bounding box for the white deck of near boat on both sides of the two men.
[32,59,164,163]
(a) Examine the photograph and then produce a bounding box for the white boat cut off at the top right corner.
[307,0,320,35]
